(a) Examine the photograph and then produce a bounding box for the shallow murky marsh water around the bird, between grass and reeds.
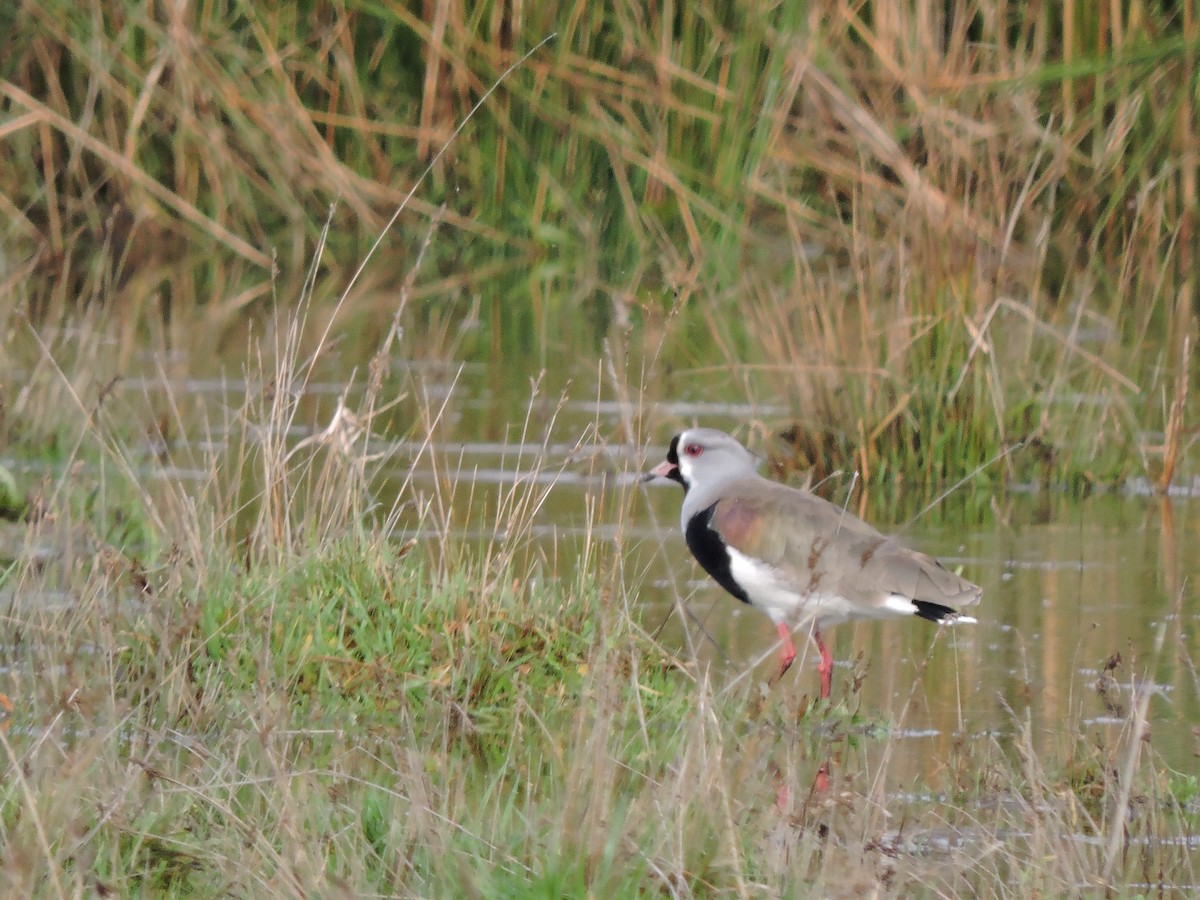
[0,336,1200,878]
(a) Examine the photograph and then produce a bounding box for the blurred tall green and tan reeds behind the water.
[0,0,1200,485]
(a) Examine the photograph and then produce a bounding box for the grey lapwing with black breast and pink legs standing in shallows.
[644,428,983,697]
